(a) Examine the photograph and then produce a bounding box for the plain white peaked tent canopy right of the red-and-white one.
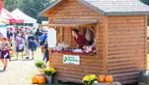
[11,9,37,23]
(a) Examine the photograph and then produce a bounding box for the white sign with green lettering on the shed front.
[63,55,80,65]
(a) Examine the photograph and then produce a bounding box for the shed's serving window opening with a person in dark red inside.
[53,27,96,55]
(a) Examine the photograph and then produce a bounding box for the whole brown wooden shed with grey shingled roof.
[40,0,149,84]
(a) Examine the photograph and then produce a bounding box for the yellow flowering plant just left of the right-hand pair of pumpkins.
[82,74,98,85]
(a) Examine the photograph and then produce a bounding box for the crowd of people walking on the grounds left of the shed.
[0,27,48,71]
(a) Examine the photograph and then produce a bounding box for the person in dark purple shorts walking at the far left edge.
[0,38,11,71]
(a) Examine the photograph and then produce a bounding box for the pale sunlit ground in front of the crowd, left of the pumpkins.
[0,48,41,85]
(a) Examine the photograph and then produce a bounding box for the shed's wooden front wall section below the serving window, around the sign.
[50,53,103,83]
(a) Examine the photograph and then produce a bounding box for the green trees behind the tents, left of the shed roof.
[4,0,56,18]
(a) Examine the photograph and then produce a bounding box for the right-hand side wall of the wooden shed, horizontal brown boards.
[107,15,147,84]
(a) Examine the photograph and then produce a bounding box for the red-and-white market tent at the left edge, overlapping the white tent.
[0,8,24,23]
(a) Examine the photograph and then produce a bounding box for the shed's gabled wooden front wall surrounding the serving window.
[49,0,105,82]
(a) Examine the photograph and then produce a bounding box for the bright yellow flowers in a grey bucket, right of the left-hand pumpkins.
[44,67,56,84]
